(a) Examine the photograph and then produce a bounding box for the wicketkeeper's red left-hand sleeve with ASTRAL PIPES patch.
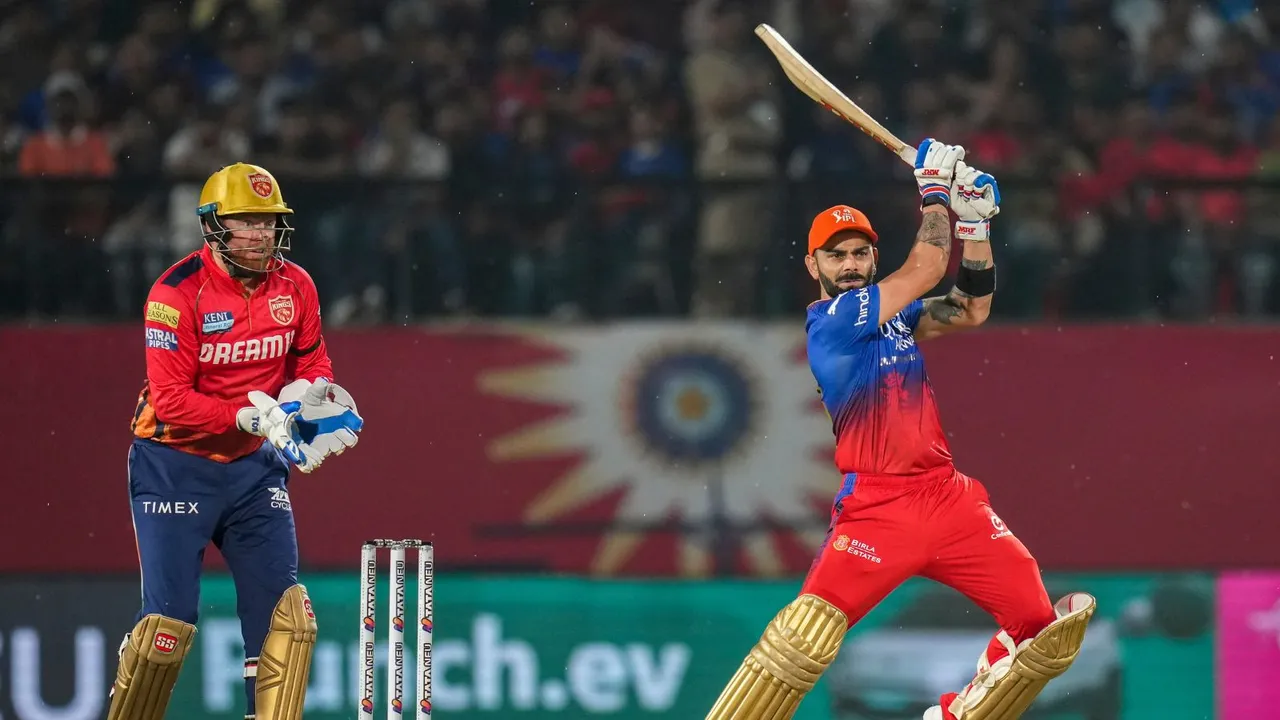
[143,283,247,433]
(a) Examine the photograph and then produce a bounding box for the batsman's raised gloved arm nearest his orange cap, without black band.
[877,138,964,325]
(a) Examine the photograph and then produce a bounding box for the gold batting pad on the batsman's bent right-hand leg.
[948,592,1097,720]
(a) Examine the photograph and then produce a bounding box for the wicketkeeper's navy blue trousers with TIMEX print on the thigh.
[129,439,298,715]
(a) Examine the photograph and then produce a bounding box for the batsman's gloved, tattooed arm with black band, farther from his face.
[915,161,1000,340]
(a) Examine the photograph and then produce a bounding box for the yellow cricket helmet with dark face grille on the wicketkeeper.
[196,163,293,275]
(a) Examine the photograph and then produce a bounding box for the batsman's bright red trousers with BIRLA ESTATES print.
[801,468,1055,640]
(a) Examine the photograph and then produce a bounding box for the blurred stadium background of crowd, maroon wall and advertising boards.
[0,0,1280,720]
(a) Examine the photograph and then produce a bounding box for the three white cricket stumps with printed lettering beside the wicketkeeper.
[357,539,435,720]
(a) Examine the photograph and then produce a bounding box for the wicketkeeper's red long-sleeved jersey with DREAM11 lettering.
[132,245,333,462]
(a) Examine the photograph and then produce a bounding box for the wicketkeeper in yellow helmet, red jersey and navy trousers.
[108,163,364,720]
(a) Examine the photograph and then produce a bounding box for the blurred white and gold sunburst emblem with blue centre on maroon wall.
[479,323,840,577]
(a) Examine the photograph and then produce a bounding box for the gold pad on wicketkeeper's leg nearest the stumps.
[253,585,316,720]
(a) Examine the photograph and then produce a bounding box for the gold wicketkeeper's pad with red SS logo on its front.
[106,615,196,720]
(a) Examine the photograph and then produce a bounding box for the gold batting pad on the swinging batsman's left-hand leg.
[707,594,849,720]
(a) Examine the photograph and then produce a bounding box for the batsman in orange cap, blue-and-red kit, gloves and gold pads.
[707,138,1094,720]
